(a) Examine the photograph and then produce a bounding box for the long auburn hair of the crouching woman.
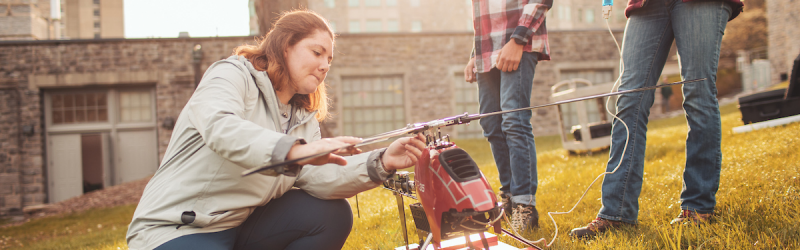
[233,10,335,121]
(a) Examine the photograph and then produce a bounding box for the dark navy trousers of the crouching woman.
[156,189,353,250]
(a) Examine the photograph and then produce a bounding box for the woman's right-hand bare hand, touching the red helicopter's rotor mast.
[381,134,426,172]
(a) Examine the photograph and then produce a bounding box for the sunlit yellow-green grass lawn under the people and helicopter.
[0,104,800,249]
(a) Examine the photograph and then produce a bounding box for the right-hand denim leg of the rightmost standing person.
[672,1,731,213]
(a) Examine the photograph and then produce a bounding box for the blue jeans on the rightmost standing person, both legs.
[597,0,731,224]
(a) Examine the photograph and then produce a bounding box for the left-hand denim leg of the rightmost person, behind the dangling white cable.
[597,0,674,224]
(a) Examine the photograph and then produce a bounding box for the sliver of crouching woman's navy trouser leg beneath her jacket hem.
[155,228,237,250]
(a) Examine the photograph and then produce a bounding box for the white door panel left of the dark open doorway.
[47,134,83,203]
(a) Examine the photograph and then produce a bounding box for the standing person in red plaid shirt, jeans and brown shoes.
[464,0,553,230]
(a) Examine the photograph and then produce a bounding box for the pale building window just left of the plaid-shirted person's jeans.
[453,72,483,139]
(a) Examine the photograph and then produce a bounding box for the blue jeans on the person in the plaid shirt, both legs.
[477,52,538,205]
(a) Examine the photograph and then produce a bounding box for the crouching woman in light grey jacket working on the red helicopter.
[127,11,425,250]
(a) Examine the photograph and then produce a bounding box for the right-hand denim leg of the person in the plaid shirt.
[500,52,538,206]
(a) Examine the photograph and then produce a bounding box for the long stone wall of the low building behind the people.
[0,30,632,214]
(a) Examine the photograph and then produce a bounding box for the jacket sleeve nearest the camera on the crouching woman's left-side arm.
[184,61,287,168]
